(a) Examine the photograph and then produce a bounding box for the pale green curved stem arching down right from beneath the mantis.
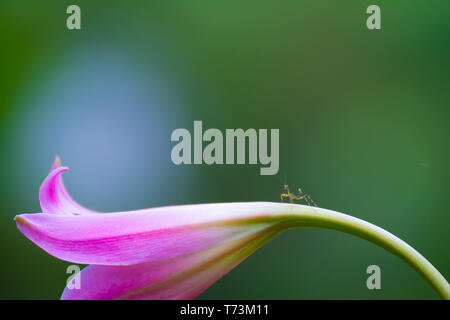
[268,203,450,300]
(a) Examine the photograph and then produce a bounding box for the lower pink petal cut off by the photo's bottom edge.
[61,226,275,300]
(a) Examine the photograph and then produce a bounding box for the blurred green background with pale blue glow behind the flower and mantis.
[0,0,450,299]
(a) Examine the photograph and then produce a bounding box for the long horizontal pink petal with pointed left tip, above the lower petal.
[16,202,287,265]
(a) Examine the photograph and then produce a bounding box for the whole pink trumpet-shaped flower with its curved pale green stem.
[15,158,450,299]
